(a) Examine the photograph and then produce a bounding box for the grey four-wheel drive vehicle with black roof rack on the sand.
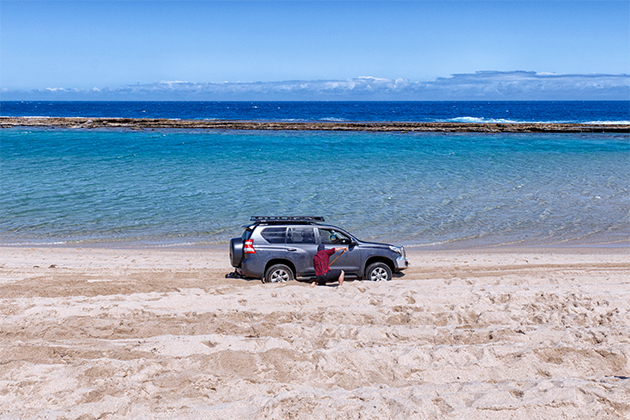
[230,216,409,283]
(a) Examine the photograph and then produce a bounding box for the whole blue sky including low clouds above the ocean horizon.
[0,0,630,100]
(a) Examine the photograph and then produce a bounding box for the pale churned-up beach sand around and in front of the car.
[0,246,630,420]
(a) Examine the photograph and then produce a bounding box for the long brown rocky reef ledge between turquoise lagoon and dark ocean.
[0,117,630,133]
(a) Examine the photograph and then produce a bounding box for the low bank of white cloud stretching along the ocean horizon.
[2,71,630,100]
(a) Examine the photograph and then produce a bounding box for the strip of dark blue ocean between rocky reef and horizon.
[0,101,630,124]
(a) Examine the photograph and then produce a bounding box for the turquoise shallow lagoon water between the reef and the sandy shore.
[0,129,630,247]
